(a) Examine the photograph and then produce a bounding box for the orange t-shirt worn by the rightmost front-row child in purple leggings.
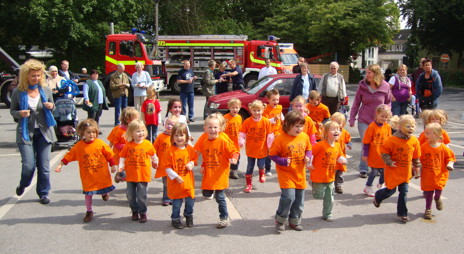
[421,143,456,191]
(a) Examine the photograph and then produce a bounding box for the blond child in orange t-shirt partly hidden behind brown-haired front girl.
[153,115,179,206]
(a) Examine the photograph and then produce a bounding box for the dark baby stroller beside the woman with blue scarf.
[53,99,78,148]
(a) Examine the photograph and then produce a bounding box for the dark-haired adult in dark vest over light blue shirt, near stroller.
[82,70,108,126]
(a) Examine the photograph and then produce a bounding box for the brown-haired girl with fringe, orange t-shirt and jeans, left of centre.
[160,123,198,229]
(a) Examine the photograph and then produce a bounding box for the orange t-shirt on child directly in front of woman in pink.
[362,121,391,168]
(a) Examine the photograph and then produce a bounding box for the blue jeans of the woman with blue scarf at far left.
[18,128,52,198]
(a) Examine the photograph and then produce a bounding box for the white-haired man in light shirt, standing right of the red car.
[318,62,346,115]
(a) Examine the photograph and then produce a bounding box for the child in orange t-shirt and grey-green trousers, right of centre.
[309,121,346,222]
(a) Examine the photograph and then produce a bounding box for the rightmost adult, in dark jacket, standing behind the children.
[416,58,443,110]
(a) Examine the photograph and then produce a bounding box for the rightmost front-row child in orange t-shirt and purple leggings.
[420,123,456,220]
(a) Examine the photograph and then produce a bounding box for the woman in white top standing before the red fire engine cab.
[132,62,152,111]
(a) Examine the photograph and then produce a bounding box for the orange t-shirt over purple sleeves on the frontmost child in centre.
[269,132,312,189]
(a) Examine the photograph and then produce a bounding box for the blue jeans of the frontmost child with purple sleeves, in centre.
[275,189,305,225]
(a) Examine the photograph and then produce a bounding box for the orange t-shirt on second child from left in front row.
[121,139,156,183]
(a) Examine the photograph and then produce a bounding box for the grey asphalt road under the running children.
[0,85,464,253]
